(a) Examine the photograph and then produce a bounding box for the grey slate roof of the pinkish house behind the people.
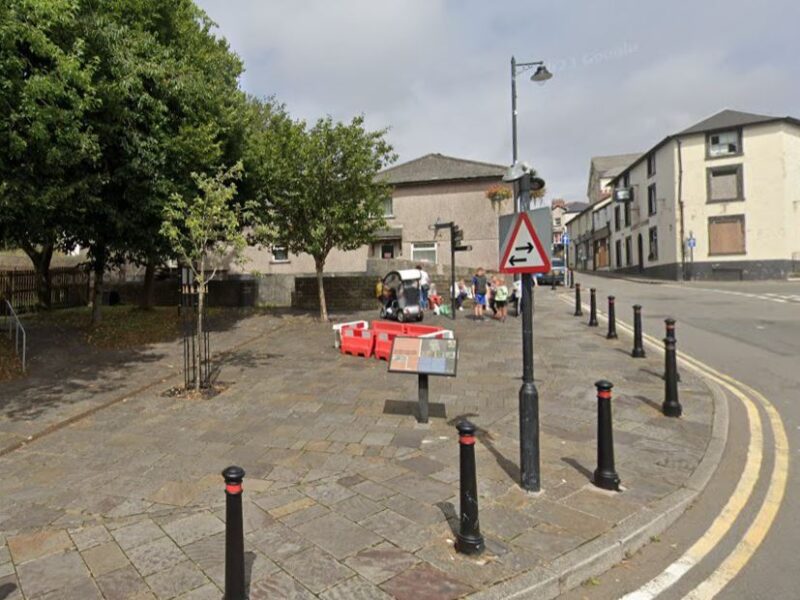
[378,154,508,184]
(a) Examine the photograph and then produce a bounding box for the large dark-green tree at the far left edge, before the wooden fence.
[0,0,100,307]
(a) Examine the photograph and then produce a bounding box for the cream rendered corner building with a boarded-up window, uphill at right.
[573,110,800,280]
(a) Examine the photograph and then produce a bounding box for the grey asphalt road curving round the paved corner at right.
[556,274,800,600]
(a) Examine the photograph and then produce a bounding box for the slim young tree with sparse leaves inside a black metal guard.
[161,163,247,391]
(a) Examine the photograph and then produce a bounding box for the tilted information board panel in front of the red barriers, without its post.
[389,337,458,377]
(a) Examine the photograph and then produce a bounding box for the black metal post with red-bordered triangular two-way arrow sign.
[500,173,552,492]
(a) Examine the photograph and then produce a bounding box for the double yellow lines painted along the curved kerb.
[561,297,789,600]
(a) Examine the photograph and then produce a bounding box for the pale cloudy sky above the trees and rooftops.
[197,0,800,200]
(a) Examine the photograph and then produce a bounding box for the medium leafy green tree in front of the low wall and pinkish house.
[250,111,396,320]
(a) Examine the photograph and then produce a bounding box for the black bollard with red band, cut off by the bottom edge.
[222,467,247,600]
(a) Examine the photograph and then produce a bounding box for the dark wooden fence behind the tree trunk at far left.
[0,267,89,312]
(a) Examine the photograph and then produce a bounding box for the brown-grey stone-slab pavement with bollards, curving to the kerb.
[0,288,727,600]
